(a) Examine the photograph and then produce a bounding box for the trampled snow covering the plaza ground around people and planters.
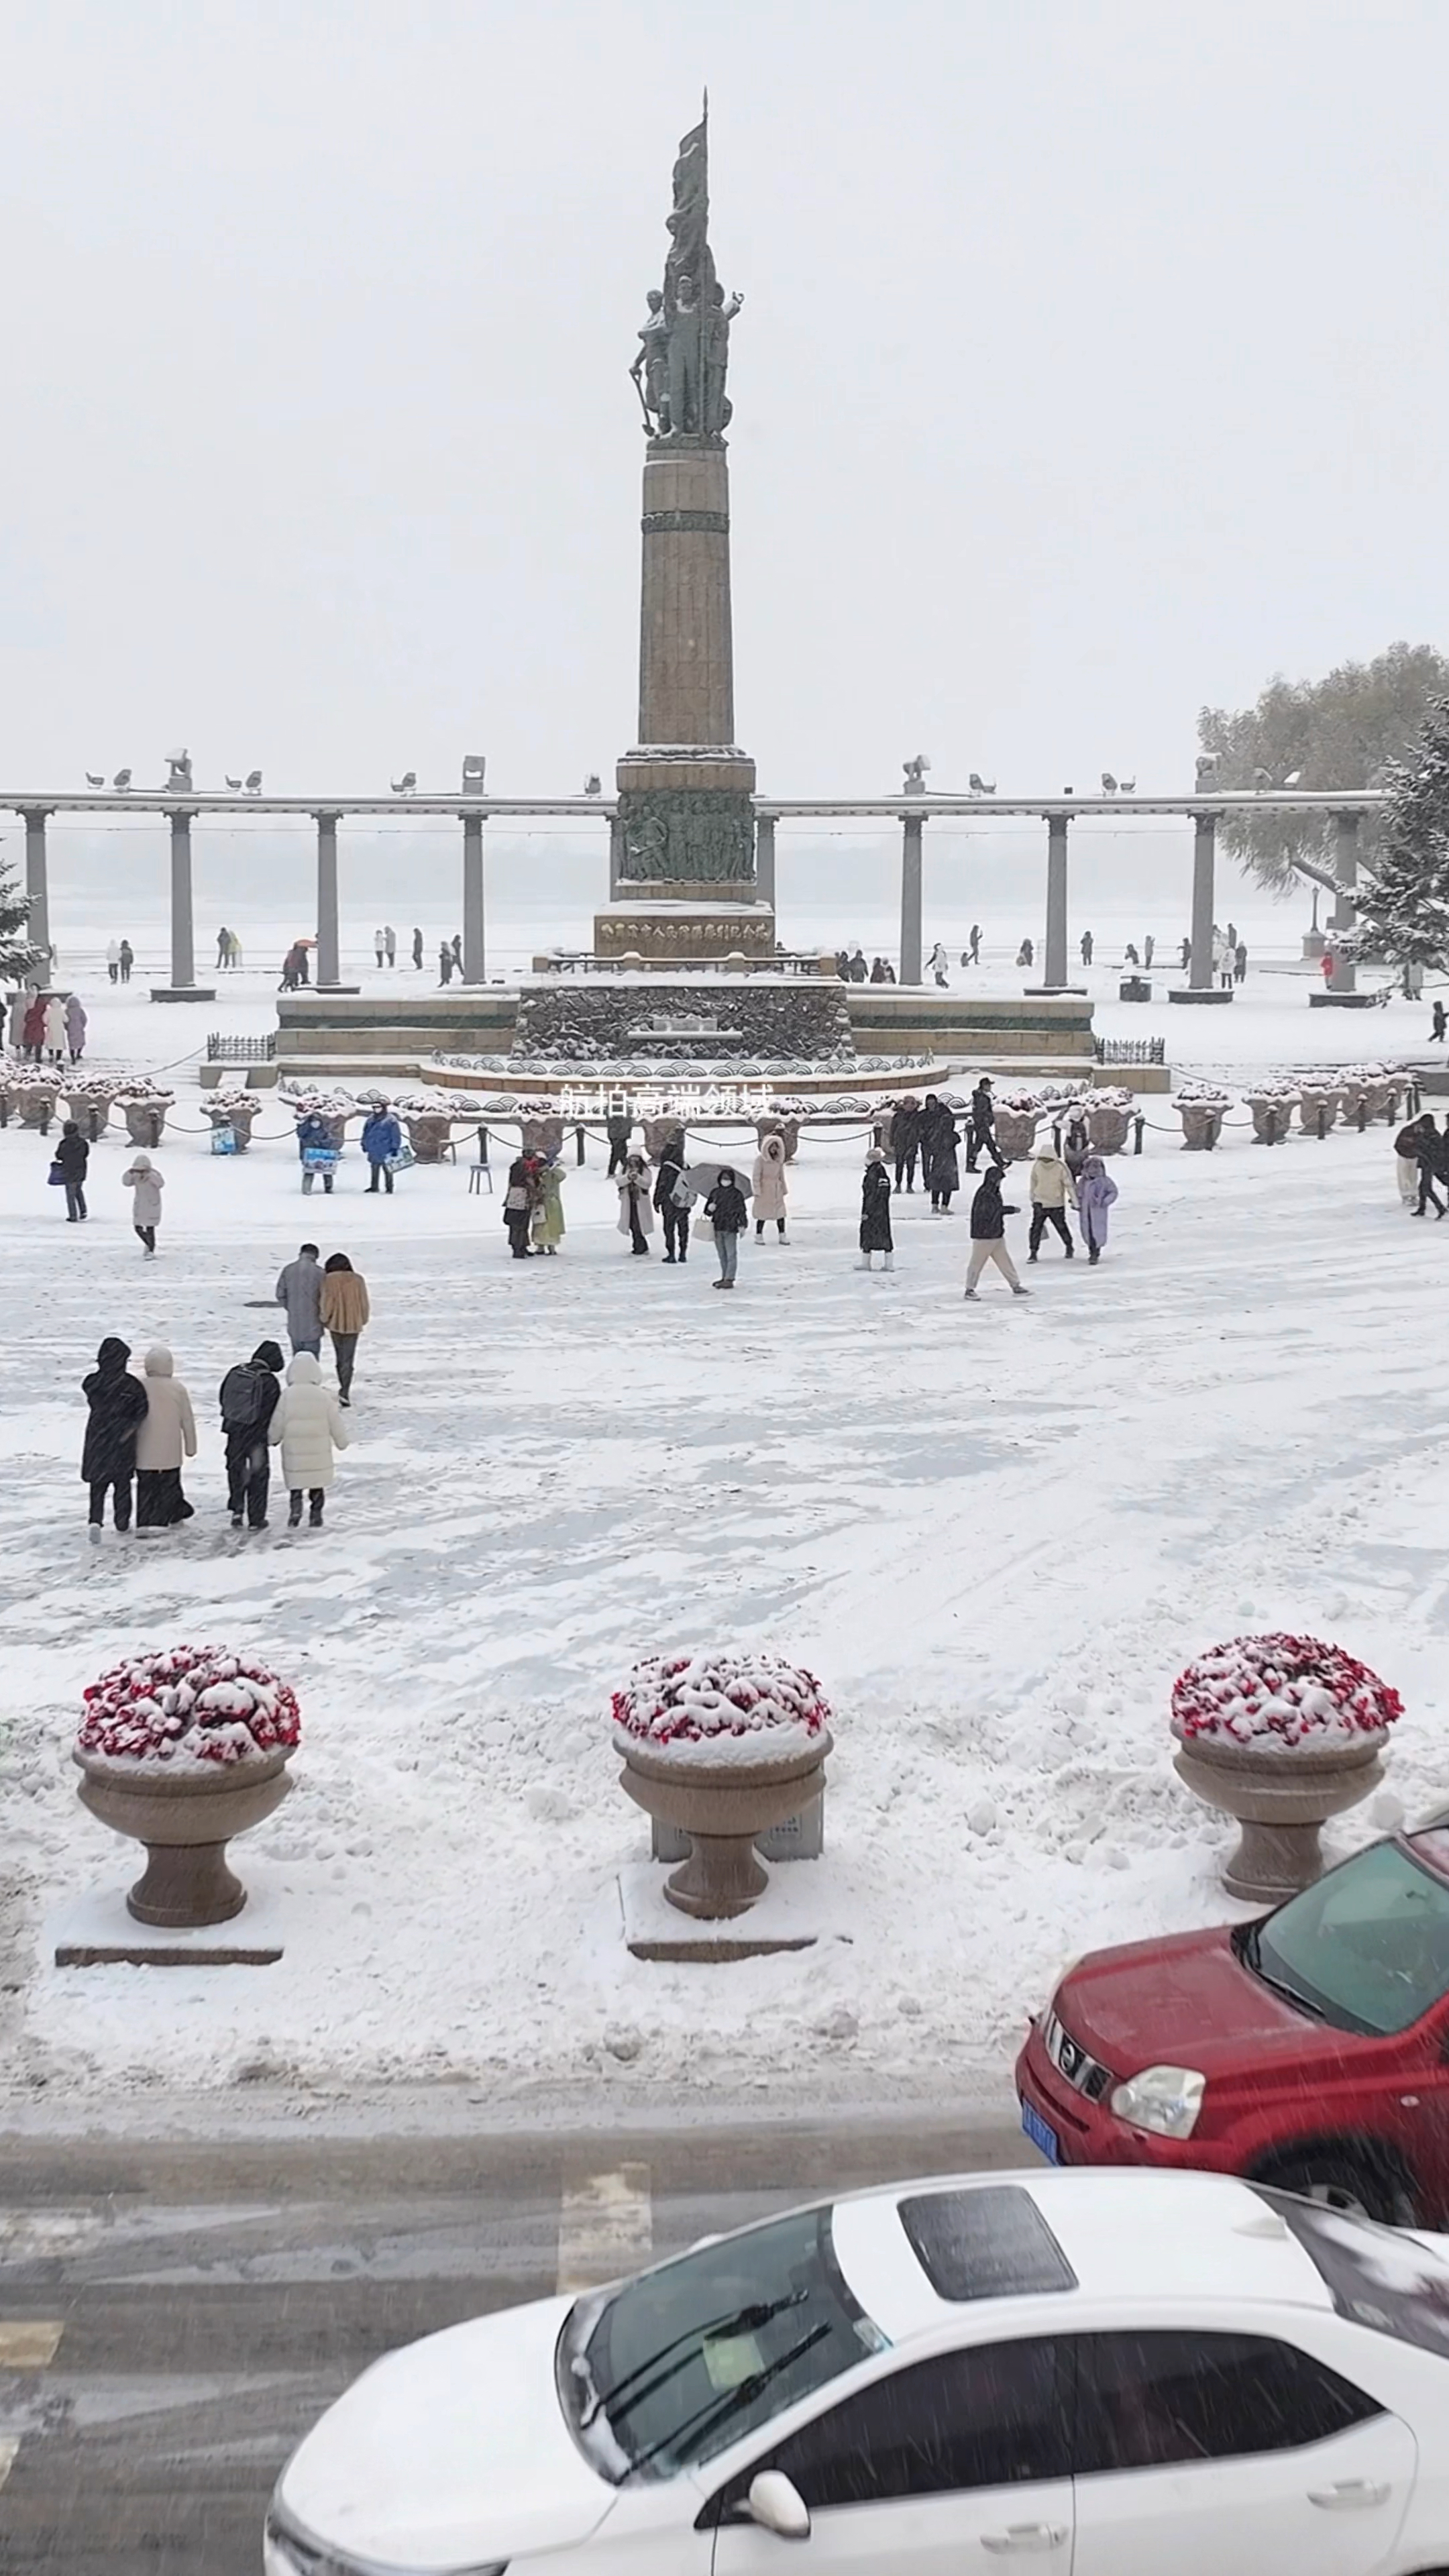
[0,1002,1449,2102]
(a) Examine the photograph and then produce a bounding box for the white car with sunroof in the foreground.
[266,2169,1449,2576]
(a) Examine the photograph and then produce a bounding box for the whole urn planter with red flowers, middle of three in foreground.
[614,1651,833,1922]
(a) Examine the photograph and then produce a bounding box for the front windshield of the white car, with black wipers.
[557,2208,887,2486]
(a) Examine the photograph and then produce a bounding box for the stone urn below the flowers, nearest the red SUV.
[1173,1718,1387,1907]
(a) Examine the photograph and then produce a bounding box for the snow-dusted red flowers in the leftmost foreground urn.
[74,1646,302,1767]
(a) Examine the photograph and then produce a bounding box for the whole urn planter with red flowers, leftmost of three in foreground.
[72,1646,302,1929]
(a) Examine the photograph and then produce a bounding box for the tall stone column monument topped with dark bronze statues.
[593,101,776,966]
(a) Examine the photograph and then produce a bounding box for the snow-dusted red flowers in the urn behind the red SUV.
[1173,1631,1403,1752]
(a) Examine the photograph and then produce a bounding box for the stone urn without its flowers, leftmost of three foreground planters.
[72,1747,291,1929]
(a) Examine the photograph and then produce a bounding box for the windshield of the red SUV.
[1238,1842,1449,2037]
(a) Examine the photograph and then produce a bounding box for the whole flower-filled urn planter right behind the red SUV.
[1173,1633,1403,1904]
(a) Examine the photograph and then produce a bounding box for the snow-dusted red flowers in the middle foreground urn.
[614,1651,830,1762]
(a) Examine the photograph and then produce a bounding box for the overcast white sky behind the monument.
[0,0,1449,794]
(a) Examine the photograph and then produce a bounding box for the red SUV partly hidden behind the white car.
[1016,1813,1449,2226]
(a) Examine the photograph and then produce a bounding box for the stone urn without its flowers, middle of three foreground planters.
[619,1729,830,1922]
